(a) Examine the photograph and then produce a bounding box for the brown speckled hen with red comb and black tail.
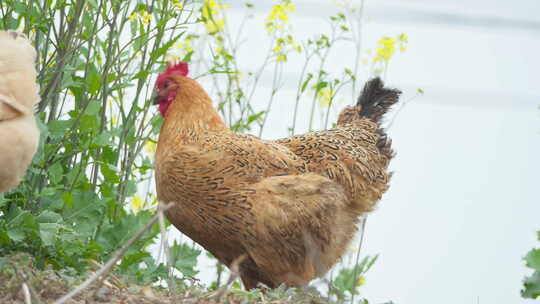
[155,63,400,289]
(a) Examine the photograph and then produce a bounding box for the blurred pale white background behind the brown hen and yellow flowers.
[175,0,540,304]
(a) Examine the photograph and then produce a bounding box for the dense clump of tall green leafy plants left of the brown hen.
[0,0,196,283]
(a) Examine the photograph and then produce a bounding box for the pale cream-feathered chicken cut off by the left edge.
[0,31,39,193]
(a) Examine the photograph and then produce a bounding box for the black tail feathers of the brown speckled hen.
[356,77,401,124]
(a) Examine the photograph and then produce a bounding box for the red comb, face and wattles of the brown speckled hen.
[154,62,188,116]
